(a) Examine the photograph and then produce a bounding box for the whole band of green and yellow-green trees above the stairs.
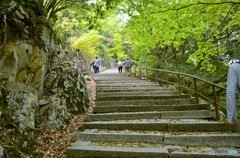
[50,0,240,82]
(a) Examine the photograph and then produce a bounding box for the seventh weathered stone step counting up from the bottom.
[97,94,191,101]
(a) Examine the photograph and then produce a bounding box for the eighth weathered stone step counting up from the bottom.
[97,91,178,97]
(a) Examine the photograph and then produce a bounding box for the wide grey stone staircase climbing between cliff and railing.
[67,71,240,158]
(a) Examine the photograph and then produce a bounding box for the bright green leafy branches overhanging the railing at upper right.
[114,0,240,81]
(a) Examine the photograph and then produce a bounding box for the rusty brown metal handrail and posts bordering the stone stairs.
[131,66,230,120]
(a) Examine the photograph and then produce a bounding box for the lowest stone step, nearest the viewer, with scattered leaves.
[67,141,240,158]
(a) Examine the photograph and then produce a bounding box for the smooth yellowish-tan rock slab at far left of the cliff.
[0,41,47,129]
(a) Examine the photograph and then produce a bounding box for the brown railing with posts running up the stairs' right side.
[131,66,239,120]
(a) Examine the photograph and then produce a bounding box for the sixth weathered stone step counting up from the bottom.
[96,98,196,106]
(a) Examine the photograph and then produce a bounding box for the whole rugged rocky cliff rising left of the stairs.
[0,1,88,130]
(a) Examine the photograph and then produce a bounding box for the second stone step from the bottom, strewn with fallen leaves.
[77,131,240,147]
